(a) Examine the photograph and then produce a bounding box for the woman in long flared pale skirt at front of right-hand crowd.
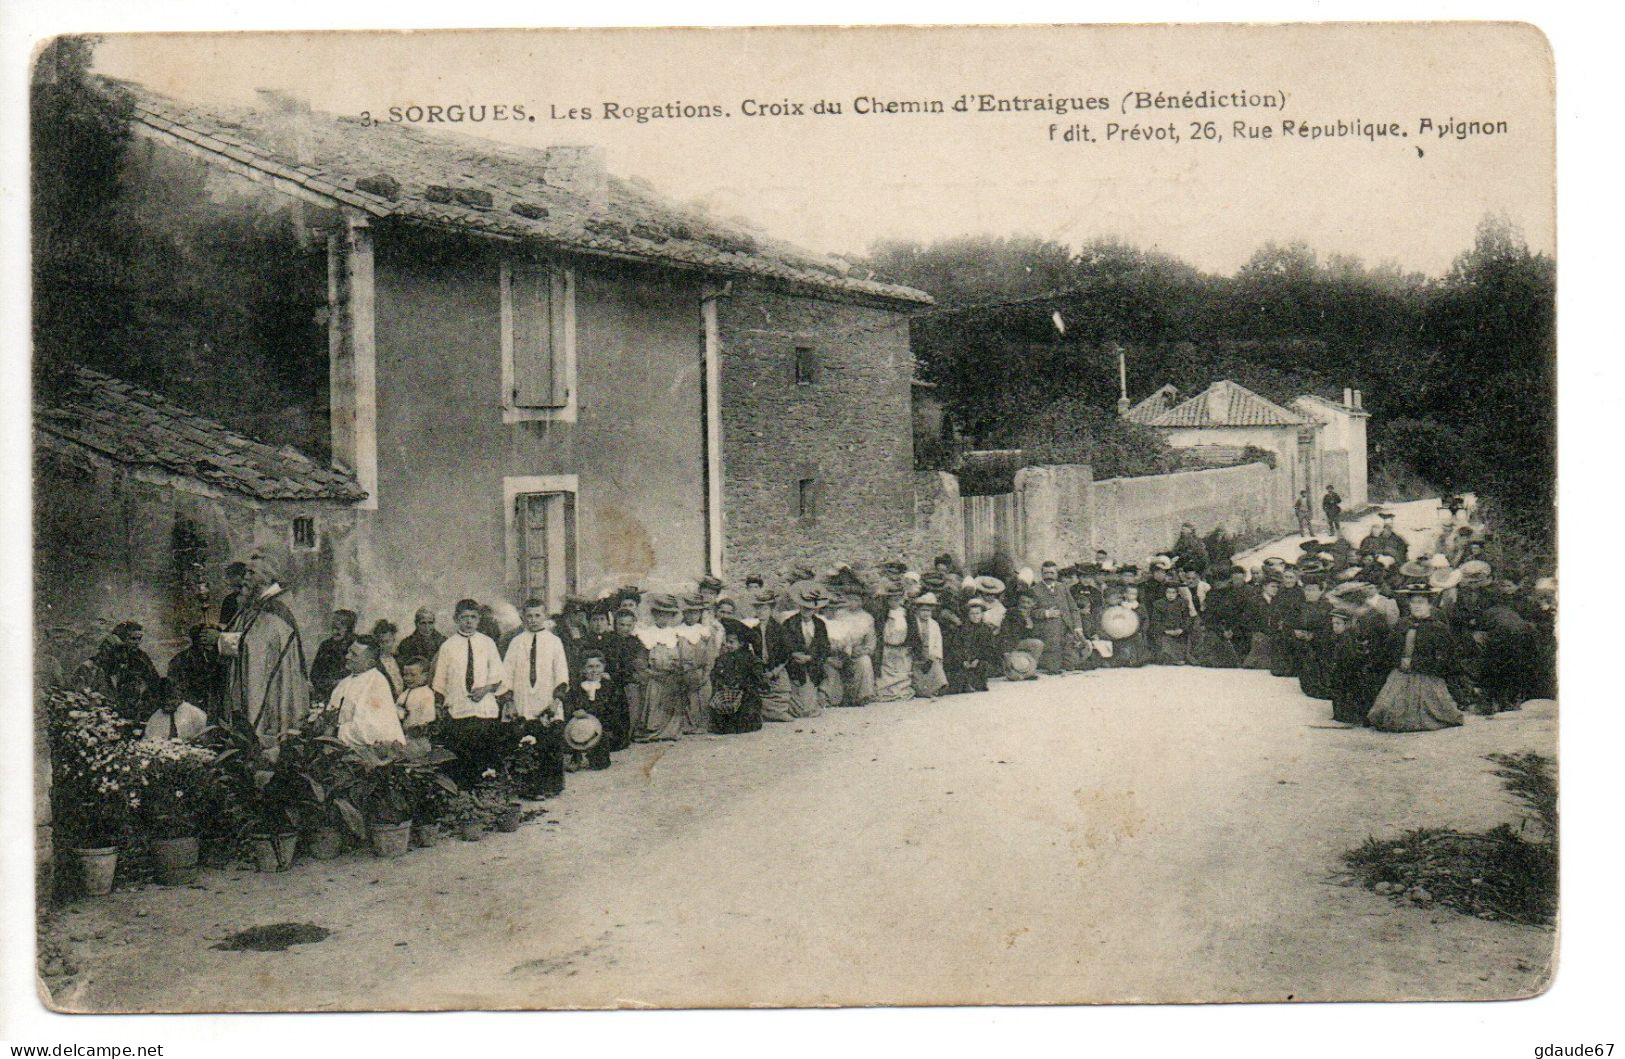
[1367,580,1461,733]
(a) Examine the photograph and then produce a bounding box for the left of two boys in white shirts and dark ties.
[429,599,509,788]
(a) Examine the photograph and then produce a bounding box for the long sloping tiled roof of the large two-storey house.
[115,81,931,305]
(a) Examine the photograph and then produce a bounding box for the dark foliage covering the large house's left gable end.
[29,37,330,456]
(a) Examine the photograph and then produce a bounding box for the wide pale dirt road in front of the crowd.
[47,668,1555,1010]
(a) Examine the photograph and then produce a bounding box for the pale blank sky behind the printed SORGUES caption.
[98,23,1555,274]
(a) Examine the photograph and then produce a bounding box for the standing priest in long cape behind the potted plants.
[216,554,310,747]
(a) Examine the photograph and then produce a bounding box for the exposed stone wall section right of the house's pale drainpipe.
[717,289,915,580]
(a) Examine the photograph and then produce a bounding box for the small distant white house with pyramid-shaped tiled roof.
[1125,380,1367,525]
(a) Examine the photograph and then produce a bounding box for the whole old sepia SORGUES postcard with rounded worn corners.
[29,23,1558,1012]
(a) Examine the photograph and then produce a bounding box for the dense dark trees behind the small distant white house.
[871,216,1557,538]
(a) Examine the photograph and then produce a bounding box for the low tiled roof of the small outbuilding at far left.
[34,367,367,500]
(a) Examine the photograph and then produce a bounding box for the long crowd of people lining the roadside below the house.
[47,510,1557,794]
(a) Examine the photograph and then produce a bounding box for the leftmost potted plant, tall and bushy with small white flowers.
[46,689,135,897]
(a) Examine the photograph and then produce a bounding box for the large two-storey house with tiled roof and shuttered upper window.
[38,84,930,636]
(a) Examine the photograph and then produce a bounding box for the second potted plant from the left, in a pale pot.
[130,741,218,885]
